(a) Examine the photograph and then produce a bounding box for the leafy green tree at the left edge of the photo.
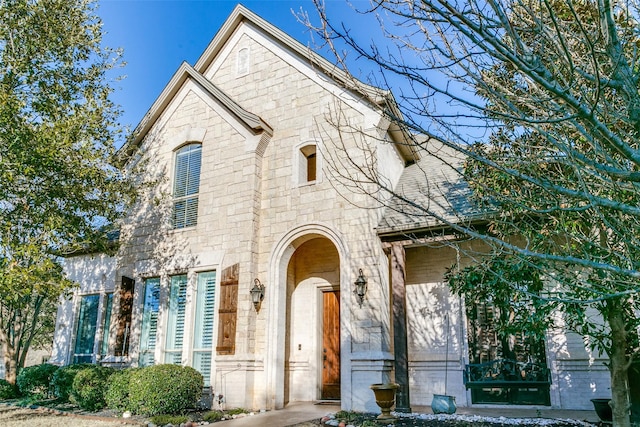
[0,0,133,383]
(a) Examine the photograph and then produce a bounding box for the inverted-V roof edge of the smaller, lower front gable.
[117,62,273,164]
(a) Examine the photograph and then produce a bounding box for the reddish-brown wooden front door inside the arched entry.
[322,291,340,399]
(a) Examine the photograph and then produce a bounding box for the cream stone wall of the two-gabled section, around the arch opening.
[102,20,401,414]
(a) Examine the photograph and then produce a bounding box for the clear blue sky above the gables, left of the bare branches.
[98,0,369,137]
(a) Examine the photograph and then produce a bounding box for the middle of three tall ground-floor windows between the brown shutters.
[164,274,187,364]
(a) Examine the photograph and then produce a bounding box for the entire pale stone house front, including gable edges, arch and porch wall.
[52,6,608,411]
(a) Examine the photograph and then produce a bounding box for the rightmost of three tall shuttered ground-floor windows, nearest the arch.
[193,271,216,387]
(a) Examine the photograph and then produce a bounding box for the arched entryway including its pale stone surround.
[265,224,353,409]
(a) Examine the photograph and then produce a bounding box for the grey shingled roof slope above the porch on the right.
[378,139,485,237]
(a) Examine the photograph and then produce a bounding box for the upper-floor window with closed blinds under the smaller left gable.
[173,144,202,228]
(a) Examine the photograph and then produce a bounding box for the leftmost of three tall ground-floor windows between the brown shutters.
[138,277,160,366]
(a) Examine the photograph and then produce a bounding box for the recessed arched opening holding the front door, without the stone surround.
[284,237,340,404]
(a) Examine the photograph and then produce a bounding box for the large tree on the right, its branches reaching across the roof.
[307,0,640,426]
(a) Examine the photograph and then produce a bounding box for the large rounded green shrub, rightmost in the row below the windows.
[129,365,204,416]
